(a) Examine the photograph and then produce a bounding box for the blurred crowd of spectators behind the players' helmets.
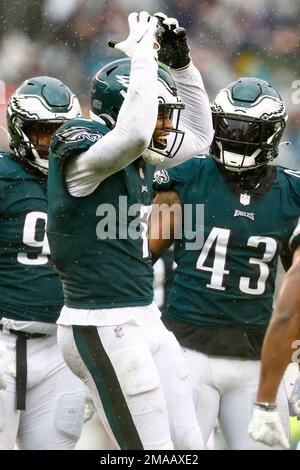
[0,0,300,170]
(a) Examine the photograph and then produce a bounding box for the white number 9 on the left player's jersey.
[17,211,50,265]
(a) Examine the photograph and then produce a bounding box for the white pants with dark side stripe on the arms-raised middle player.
[58,306,203,450]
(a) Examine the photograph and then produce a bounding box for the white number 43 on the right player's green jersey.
[196,227,277,295]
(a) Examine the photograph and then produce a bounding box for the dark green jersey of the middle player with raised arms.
[47,118,154,309]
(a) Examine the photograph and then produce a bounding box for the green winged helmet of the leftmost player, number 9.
[7,76,81,174]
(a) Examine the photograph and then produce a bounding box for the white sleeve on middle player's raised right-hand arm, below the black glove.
[158,63,213,169]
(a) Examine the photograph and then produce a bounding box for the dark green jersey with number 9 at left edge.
[0,153,63,323]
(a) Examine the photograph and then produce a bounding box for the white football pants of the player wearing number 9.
[0,331,86,450]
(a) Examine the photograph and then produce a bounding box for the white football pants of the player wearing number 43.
[184,349,289,450]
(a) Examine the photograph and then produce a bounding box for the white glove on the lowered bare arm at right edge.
[248,405,290,449]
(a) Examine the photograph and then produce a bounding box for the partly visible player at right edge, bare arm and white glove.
[248,244,300,448]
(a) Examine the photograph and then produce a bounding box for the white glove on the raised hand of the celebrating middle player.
[108,11,159,59]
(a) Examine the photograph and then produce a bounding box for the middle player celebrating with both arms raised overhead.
[47,12,212,449]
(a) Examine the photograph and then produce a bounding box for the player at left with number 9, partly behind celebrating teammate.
[0,76,85,450]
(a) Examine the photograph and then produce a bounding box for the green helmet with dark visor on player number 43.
[211,77,287,172]
